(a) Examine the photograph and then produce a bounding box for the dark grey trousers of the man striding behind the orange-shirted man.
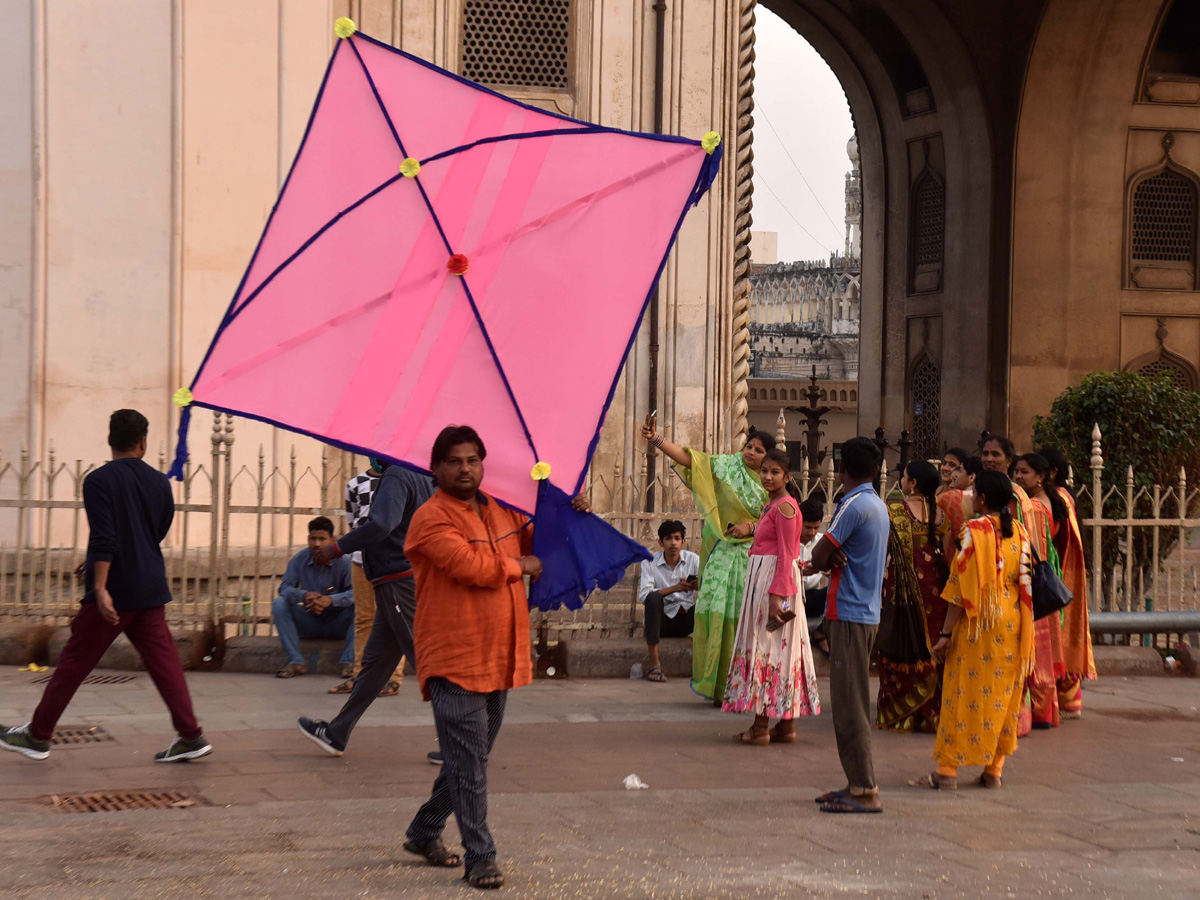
[329,578,416,749]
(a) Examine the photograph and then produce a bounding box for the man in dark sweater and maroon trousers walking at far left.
[0,409,212,762]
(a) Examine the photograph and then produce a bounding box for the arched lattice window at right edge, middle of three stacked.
[1132,169,1196,263]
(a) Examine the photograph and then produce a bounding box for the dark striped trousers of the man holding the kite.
[406,678,509,871]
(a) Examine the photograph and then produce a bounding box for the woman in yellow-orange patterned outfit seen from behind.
[910,472,1033,791]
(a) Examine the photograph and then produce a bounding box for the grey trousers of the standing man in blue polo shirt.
[824,619,878,791]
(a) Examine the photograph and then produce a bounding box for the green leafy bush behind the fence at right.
[1033,372,1200,595]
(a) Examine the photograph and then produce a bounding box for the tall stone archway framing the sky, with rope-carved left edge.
[733,0,1008,451]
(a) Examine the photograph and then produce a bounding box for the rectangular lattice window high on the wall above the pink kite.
[462,0,571,91]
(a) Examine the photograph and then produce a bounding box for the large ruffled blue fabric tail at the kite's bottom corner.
[529,481,652,611]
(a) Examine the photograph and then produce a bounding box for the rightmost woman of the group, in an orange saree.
[1038,446,1096,719]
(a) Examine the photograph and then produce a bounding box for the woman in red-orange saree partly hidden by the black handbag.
[1013,454,1067,728]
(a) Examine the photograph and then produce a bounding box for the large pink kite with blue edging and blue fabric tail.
[173,19,720,608]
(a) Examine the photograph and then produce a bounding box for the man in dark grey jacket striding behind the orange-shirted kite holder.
[300,466,442,764]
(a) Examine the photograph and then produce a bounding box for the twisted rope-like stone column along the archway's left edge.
[732,0,757,450]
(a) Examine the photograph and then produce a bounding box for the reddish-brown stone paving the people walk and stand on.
[0,668,1200,900]
